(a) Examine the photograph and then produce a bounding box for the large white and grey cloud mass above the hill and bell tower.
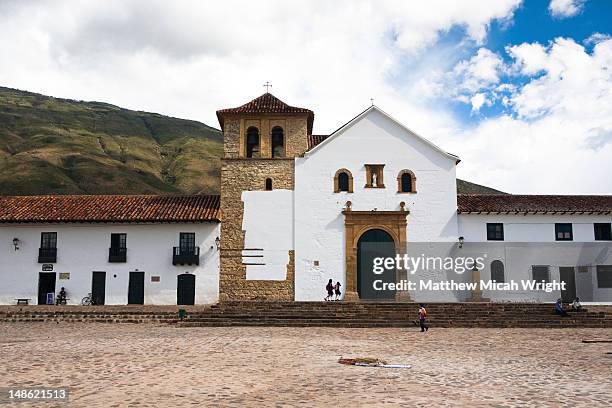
[0,0,520,133]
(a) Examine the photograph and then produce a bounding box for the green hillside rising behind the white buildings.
[0,87,499,195]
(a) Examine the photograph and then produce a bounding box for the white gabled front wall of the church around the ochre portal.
[295,109,457,300]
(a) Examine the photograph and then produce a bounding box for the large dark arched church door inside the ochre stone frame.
[357,229,396,300]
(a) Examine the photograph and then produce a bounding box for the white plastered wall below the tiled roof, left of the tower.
[0,222,219,305]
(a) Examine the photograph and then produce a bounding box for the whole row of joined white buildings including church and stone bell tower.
[0,93,612,304]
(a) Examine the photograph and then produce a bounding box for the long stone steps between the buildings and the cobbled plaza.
[0,301,612,328]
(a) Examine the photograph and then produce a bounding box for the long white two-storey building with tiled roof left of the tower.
[0,195,219,305]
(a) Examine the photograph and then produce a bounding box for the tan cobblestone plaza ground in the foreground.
[0,323,612,407]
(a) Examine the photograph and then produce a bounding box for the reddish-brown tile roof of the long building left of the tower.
[0,195,220,223]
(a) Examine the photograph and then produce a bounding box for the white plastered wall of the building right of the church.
[459,214,612,302]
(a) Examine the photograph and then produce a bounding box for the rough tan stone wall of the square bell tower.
[219,108,308,300]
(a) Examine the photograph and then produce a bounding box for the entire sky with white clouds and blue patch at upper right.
[0,0,612,194]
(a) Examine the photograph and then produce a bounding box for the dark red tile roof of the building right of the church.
[457,194,612,214]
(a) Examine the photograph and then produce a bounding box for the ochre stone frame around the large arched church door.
[342,209,409,301]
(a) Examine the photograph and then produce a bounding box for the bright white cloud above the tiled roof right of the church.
[449,38,612,194]
